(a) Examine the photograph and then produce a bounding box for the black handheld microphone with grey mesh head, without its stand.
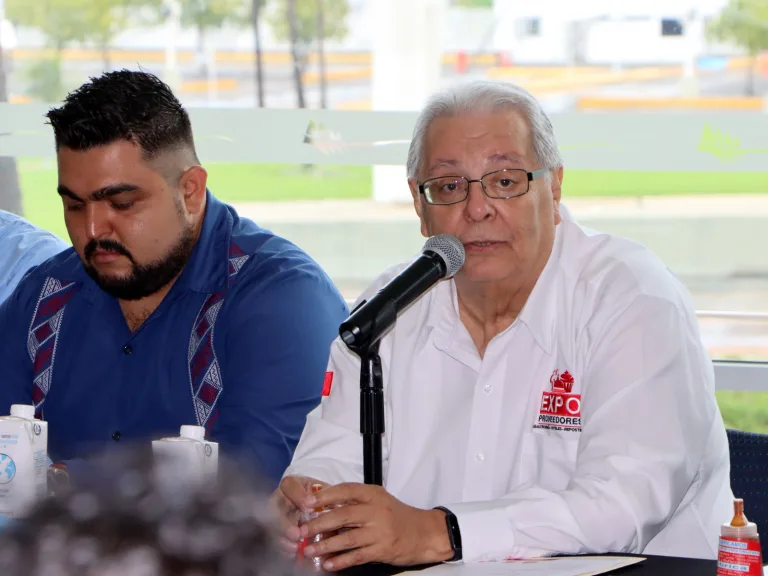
[339,234,464,351]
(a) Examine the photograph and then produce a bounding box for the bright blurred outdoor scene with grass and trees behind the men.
[0,0,768,432]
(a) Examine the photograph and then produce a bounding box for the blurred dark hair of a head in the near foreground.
[0,450,292,576]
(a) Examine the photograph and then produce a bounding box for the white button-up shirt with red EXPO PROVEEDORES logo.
[286,214,733,561]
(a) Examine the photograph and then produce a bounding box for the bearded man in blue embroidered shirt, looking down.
[0,71,347,481]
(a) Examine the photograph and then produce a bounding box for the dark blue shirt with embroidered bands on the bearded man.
[0,193,348,481]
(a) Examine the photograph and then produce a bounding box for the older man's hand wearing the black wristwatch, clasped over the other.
[300,484,453,571]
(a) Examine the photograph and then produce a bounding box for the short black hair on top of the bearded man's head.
[46,70,197,160]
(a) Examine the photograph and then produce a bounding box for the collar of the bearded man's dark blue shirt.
[75,190,234,302]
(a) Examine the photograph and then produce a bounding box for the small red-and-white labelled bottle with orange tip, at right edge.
[717,498,763,576]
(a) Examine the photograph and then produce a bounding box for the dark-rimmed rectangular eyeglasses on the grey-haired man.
[419,168,549,206]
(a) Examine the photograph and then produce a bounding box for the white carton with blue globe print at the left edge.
[0,404,48,520]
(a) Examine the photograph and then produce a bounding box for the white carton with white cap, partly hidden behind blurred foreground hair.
[152,426,219,485]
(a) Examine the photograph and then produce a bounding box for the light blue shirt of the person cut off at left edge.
[0,210,68,302]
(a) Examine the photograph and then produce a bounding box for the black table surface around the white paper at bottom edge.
[343,554,717,576]
